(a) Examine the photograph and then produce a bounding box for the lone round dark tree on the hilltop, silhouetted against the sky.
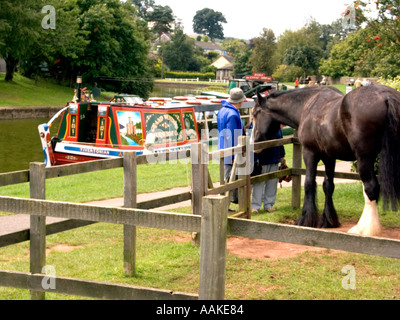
[193,8,227,39]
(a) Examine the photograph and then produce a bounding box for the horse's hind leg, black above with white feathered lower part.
[349,158,382,236]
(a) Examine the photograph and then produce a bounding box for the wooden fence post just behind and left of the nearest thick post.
[190,143,208,245]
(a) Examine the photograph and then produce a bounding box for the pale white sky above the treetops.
[155,0,360,40]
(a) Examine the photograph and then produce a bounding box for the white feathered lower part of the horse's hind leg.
[349,186,382,237]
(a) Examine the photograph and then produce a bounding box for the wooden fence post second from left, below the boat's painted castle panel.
[124,151,137,277]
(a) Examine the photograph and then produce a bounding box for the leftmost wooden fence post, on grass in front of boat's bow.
[29,162,46,300]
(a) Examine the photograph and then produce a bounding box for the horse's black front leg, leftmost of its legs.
[296,148,319,228]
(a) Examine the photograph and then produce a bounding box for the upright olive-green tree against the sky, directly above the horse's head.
[250,28,277,75]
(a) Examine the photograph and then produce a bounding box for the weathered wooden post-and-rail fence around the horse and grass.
[0,133,400,300]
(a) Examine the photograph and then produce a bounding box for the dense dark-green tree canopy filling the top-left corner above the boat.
[0,0,152,96]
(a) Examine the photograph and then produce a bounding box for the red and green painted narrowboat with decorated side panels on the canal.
[38,79,254,167]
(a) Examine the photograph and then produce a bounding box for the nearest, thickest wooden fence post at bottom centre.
[199,195,229,300]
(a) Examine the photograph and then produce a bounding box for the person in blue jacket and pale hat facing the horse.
[217,88,246,203]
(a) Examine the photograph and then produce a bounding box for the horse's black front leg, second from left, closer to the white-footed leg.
[319,158,340,228]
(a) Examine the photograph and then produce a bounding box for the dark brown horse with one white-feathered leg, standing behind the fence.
[253,85,400,235]
